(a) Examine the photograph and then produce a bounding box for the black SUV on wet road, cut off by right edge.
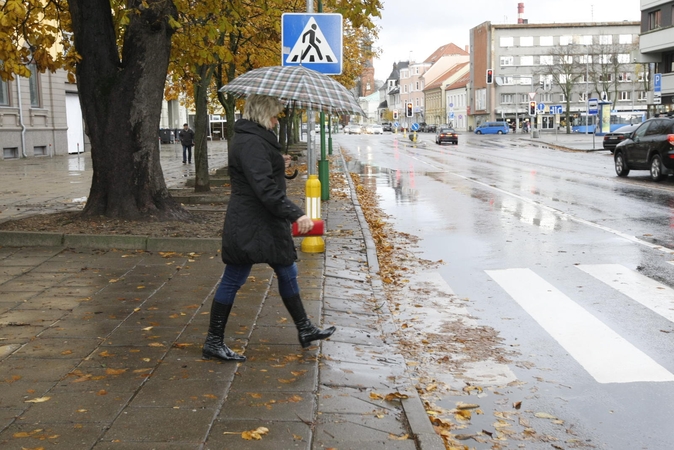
[613,118,674,181]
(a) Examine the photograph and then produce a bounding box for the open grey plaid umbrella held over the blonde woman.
[220,66,366,116]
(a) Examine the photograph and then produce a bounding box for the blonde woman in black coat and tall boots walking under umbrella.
[202,95,335,361]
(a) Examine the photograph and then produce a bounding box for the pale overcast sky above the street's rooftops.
[374,0,641,80]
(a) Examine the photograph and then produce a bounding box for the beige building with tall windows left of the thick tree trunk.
[0,67,88,159]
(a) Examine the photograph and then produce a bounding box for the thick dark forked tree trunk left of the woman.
[68,0,189,220]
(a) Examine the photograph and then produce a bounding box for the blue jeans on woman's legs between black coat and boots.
[213,263,300,305]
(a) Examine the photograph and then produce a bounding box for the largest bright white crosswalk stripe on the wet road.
[486,269,674,383]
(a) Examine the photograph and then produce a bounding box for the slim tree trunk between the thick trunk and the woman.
[194,65,213,192]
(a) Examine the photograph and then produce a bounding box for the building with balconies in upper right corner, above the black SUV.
[634,0,674,112]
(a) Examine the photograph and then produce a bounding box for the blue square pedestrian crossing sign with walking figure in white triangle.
[281,13,343,75]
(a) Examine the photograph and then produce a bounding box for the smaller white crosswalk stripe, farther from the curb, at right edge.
[577,264,674,322]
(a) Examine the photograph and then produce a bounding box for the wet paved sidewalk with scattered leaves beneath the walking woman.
[0,146,444,450]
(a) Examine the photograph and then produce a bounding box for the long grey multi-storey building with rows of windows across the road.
[468,21,647,129]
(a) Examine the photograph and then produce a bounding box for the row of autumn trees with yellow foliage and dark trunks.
[0,0,382,214]
